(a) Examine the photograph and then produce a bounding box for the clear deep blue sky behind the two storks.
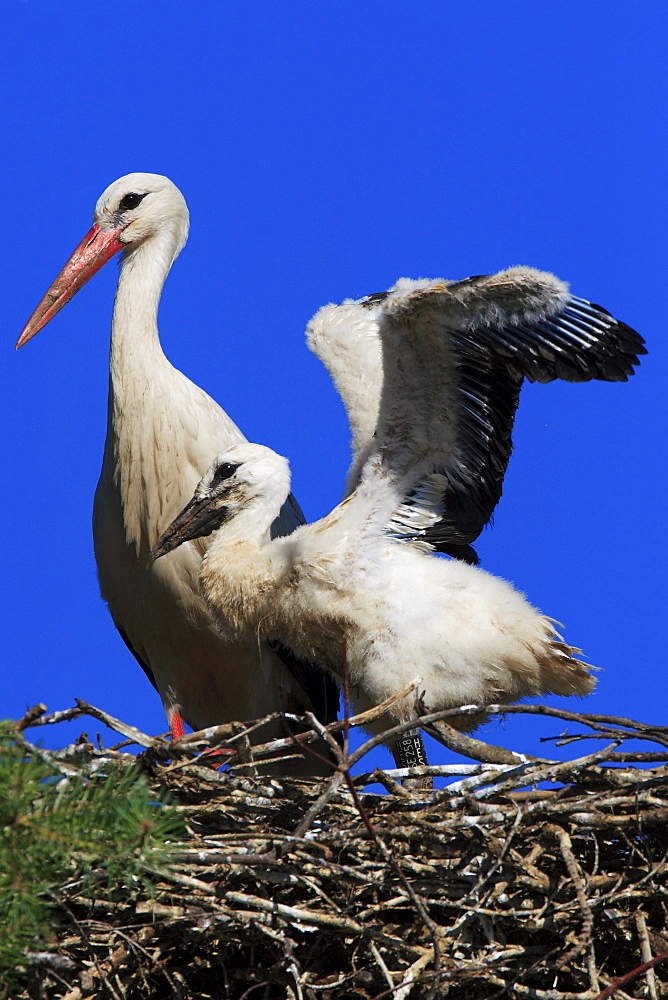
[0,0,668,763]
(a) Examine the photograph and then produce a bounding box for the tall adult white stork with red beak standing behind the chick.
[17,173,338,773]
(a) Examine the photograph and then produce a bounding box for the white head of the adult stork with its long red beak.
[16,173,189,348]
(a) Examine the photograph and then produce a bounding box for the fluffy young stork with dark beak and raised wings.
[154,268,643,760]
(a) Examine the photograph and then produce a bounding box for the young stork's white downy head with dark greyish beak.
[151,442,290,559]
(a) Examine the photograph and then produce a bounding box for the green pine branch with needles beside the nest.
[0,722,185,998]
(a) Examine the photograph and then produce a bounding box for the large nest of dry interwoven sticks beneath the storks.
[9,702,668,1000]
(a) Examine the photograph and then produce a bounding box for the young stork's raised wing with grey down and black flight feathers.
[344,267,645,558]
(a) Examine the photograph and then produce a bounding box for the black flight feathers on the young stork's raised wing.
[386,275,647,562]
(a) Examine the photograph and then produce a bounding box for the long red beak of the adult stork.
[16,225,126,350]
